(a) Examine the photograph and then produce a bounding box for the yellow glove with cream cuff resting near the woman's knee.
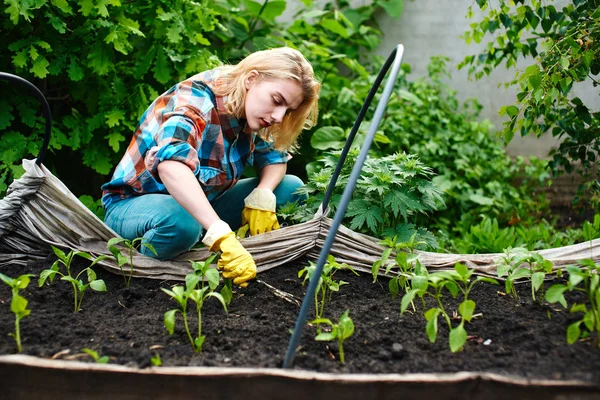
[242,188,279,236]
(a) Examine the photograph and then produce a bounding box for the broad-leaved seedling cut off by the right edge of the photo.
[546,260,600,348]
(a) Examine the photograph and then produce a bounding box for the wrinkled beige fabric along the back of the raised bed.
[0,160,600,280]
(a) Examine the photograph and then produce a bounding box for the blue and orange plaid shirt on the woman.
[102,69,289,208]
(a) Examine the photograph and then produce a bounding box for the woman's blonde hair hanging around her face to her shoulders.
[212,47,321,150]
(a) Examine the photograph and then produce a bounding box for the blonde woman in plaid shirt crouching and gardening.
[102,47,320,287]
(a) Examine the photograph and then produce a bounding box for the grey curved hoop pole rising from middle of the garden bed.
[283,44,404,368]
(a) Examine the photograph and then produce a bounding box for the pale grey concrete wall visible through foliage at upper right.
[283,0,600,157]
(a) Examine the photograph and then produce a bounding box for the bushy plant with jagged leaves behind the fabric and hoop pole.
[281,149,443,247]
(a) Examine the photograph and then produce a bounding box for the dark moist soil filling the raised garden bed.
[0,253,600,383]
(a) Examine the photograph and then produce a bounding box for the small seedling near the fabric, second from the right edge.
[496,247,553,303]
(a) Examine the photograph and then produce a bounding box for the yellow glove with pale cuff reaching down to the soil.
[202,221,256,287]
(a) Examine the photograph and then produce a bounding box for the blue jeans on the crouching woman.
[104,175,303,260]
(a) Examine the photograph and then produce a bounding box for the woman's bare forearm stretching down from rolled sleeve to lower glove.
[157,160,220,230]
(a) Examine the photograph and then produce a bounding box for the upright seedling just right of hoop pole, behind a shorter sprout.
[298,254,358,332]
